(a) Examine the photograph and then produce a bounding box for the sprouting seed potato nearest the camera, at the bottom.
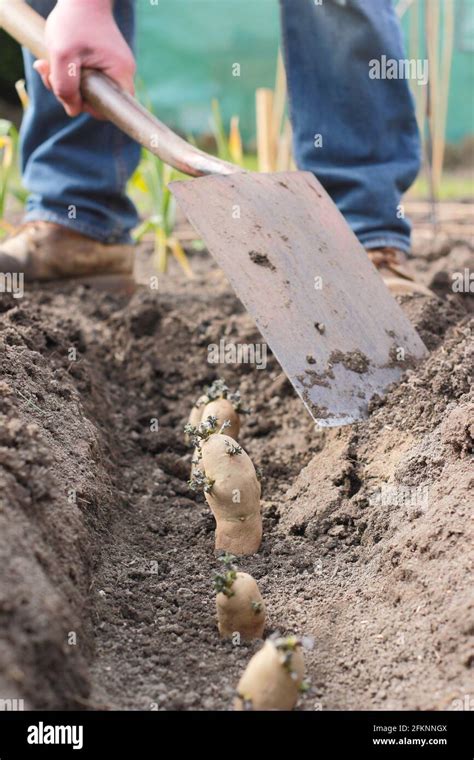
[234,639,304,710]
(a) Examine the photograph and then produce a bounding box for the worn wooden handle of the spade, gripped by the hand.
[0,0,244,177]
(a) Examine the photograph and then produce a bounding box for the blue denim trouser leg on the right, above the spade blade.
[280,0,420,251]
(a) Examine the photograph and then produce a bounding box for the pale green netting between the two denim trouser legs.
[137,0,279,139]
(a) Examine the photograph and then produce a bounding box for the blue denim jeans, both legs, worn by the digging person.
[22,0,420,251]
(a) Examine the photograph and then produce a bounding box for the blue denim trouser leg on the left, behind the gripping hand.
[21,0,140,243]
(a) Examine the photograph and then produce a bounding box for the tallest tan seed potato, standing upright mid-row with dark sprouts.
[201,433,262,555]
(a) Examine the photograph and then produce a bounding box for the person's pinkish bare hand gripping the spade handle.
[34,0,136,116]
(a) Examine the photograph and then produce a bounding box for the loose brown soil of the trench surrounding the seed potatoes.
[0,227,474,710]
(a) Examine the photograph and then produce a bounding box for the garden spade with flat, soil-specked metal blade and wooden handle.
[0,0,426,426]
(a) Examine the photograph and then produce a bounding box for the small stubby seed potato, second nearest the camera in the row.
[216,572,265,641]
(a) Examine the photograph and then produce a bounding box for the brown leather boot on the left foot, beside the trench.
[0,222,135,291]
